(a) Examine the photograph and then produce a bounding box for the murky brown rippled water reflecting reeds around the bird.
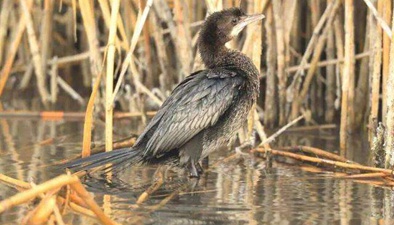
[0,110,394,224]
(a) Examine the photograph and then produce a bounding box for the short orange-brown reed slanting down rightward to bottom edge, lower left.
[70,182,116,225]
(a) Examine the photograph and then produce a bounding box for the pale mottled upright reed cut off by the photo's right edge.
[383,4,394,168]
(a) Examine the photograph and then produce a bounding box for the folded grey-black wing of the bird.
[137,69,244,157]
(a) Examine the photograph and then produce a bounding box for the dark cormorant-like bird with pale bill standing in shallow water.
[65,8,264,177]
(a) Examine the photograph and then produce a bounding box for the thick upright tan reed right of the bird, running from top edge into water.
[339,0,355,153]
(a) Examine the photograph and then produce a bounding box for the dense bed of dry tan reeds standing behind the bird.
[0,0,394,165]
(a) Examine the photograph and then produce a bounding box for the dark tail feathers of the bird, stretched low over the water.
[62,148,142,171]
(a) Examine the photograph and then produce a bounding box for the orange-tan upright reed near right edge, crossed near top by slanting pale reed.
[382,0,392,124]
